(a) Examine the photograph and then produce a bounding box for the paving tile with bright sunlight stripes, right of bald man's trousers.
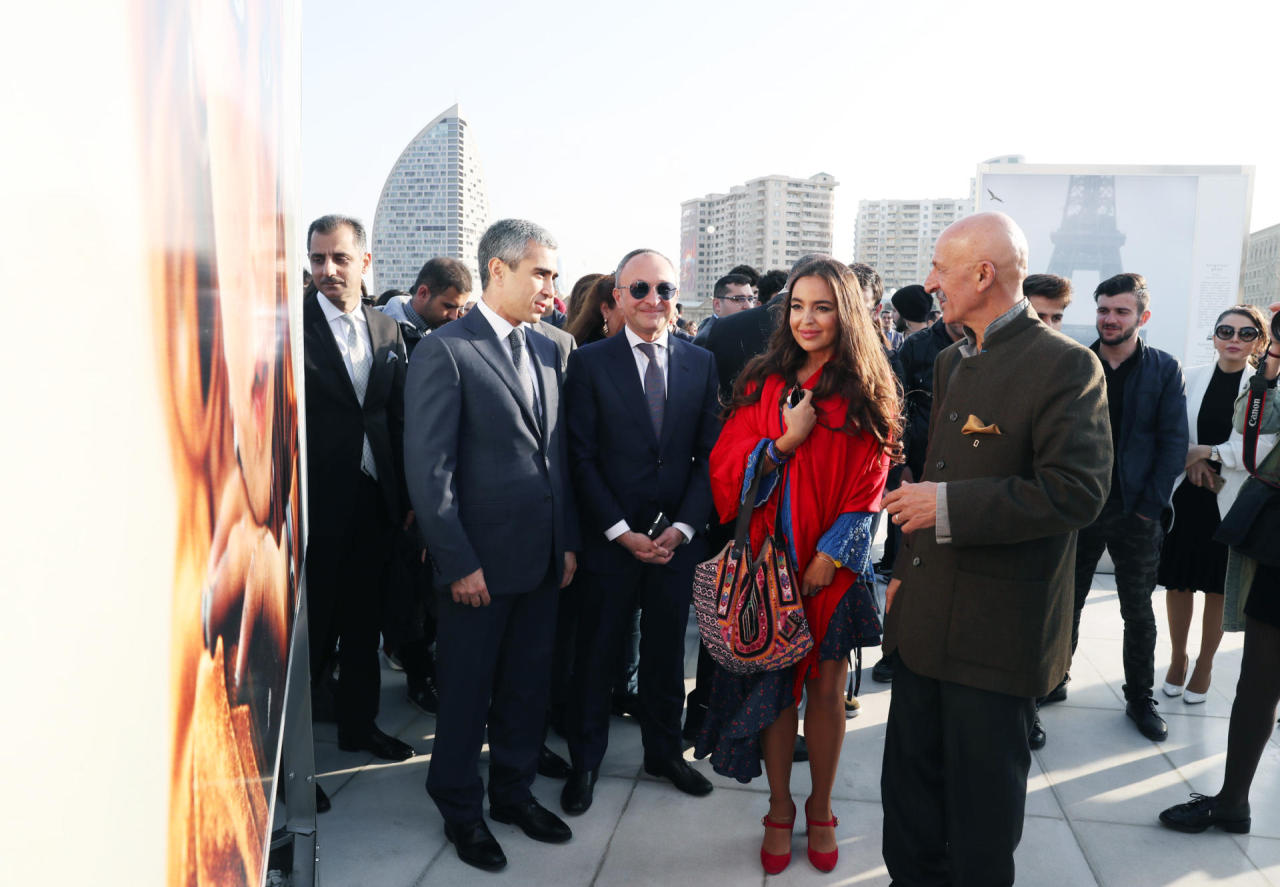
[1038,709,1188,824]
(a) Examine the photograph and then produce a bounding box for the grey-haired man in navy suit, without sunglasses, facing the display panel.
[404,219,579,870]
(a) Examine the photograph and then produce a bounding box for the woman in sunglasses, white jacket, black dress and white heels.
[1157,305,1267,705]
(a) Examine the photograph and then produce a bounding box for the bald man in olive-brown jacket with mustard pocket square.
[881,212,1111,884]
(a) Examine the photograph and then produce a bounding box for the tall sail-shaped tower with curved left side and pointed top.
[371,105,489,291]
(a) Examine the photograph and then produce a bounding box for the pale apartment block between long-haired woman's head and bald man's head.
[854,198,973,296]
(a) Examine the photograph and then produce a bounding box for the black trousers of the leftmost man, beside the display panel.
[306,476,392,737]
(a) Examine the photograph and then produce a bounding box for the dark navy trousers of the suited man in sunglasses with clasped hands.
[568,547,696,771]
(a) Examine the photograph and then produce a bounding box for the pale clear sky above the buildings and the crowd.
[300,0,1280,292]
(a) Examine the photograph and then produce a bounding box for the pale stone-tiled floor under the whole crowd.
[309,550,1280,887]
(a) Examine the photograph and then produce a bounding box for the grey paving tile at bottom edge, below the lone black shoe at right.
[1060,822,1267,887]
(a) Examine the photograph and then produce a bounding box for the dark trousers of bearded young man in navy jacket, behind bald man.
[1071,494,1164,700]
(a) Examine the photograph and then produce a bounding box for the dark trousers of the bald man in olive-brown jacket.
[881,657,1034,887]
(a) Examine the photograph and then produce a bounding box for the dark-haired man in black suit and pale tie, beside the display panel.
[302,215,413,760]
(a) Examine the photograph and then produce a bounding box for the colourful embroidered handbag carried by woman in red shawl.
[694,463,813,675]
